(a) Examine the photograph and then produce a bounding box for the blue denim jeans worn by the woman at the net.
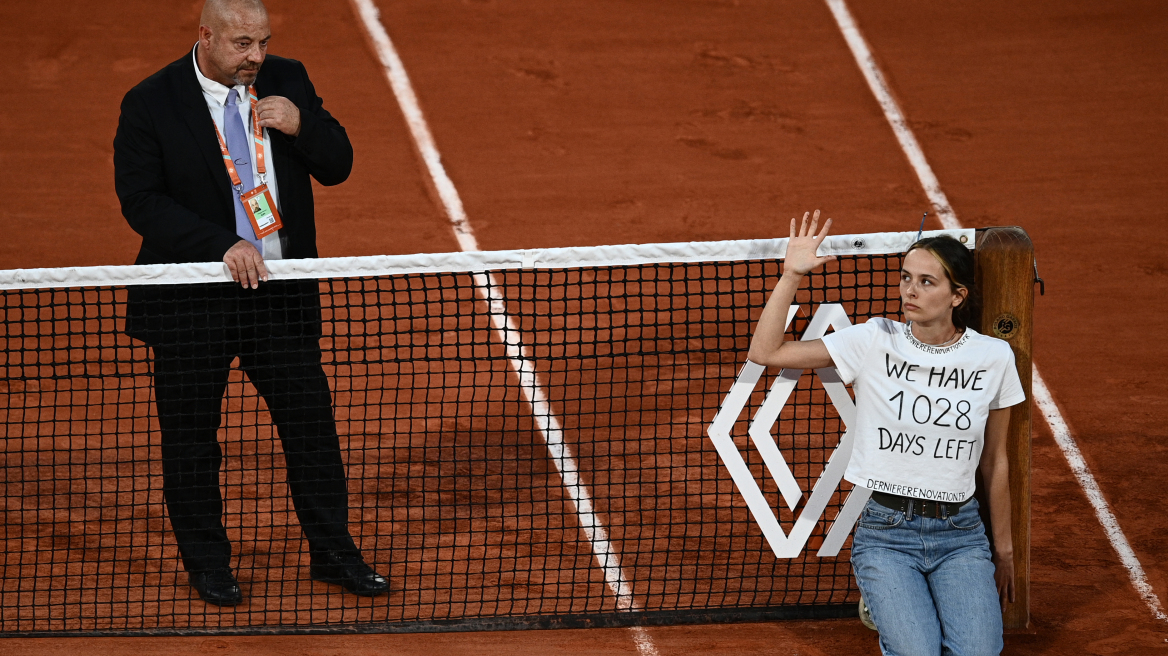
[851,500,1002,656]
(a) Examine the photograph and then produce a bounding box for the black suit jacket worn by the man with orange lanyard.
[113,51,353,346]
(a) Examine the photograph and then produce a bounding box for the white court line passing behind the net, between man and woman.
[352,0,658,656]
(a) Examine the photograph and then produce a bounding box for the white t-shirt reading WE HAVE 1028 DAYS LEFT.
[823,317,1026,502]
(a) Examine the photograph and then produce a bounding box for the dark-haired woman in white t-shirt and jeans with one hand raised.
[749,210,1026,656]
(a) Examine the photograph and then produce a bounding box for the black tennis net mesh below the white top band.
[0,249,899,635]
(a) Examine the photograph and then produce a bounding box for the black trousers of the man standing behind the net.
[153,335,357,572]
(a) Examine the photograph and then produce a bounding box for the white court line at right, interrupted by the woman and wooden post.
[826,0,1168,621]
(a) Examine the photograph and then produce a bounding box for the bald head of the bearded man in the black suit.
[196,0,272,86]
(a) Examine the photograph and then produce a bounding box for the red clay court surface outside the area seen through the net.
[0,0,1168,655]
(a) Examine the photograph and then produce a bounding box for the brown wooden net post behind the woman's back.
[974,228,1035,630]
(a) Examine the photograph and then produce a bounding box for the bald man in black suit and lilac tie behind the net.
[113,0,389,606]
